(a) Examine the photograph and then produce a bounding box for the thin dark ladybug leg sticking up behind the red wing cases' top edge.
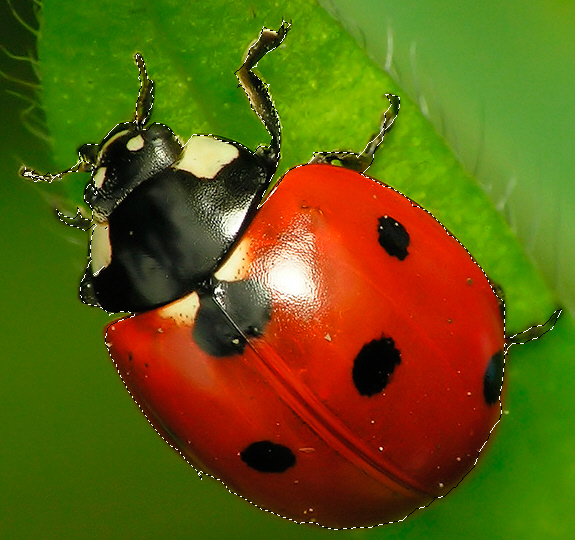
[310,94,399,172]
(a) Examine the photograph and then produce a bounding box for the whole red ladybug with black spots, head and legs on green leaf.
[21,23,564,528]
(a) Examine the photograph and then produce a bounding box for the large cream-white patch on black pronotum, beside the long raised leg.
[174,135,240,178]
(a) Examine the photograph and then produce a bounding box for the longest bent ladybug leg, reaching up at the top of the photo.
[236,21,290,170]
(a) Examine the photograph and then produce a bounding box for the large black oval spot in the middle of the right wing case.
[352,336,401,396]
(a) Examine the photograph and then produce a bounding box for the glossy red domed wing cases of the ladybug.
[106,164,505,528]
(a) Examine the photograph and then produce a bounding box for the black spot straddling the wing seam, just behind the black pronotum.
[192,279,271,357]
